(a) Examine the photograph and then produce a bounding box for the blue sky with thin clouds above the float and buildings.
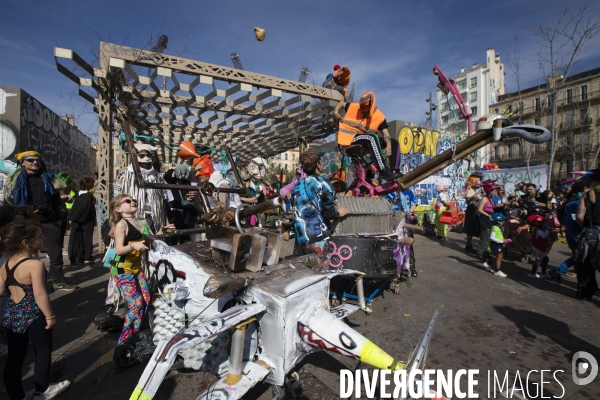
[0,0,600,141]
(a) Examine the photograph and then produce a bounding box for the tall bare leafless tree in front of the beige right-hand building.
[531,5,600,187]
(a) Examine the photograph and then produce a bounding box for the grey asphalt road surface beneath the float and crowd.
[0,233,600,400]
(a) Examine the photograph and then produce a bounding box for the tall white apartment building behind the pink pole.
[436,48,505,165]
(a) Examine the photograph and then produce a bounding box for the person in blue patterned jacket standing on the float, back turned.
[293,152,350,269]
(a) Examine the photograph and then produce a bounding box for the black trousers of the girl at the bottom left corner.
[4,316,52,400]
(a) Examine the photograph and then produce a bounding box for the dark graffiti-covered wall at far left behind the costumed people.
[0,86,92,179]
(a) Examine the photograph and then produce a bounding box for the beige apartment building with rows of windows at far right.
[489,68,600,183]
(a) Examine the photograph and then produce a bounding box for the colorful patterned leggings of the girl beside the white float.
[113,271,150,345]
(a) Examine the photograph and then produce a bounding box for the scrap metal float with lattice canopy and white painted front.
[55,43,549,399]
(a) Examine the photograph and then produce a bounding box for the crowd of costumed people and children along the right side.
[454,173,600,298]
